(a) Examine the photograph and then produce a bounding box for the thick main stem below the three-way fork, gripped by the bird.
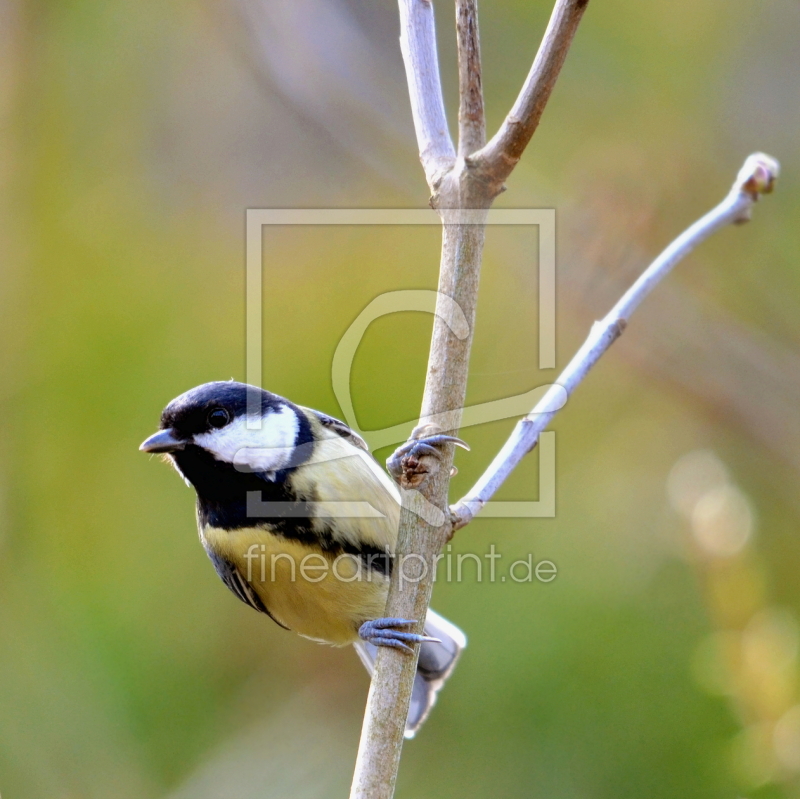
[350,216,486,799]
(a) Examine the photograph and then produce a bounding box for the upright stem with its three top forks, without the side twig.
[350,0,588,799]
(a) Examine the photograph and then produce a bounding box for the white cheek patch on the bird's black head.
[194,406,300,472]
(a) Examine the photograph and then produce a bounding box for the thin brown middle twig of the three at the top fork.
[456,0,486,158]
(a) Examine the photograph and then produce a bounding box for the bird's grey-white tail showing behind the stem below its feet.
[355,609,467,738]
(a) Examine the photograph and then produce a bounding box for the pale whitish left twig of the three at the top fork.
[399,0,456,192]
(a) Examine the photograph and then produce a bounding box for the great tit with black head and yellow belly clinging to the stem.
[140,381,466,738]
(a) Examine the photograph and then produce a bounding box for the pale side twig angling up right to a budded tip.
[451,153,779,529]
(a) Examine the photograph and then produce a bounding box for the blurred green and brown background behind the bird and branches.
[0,0,800,799]
